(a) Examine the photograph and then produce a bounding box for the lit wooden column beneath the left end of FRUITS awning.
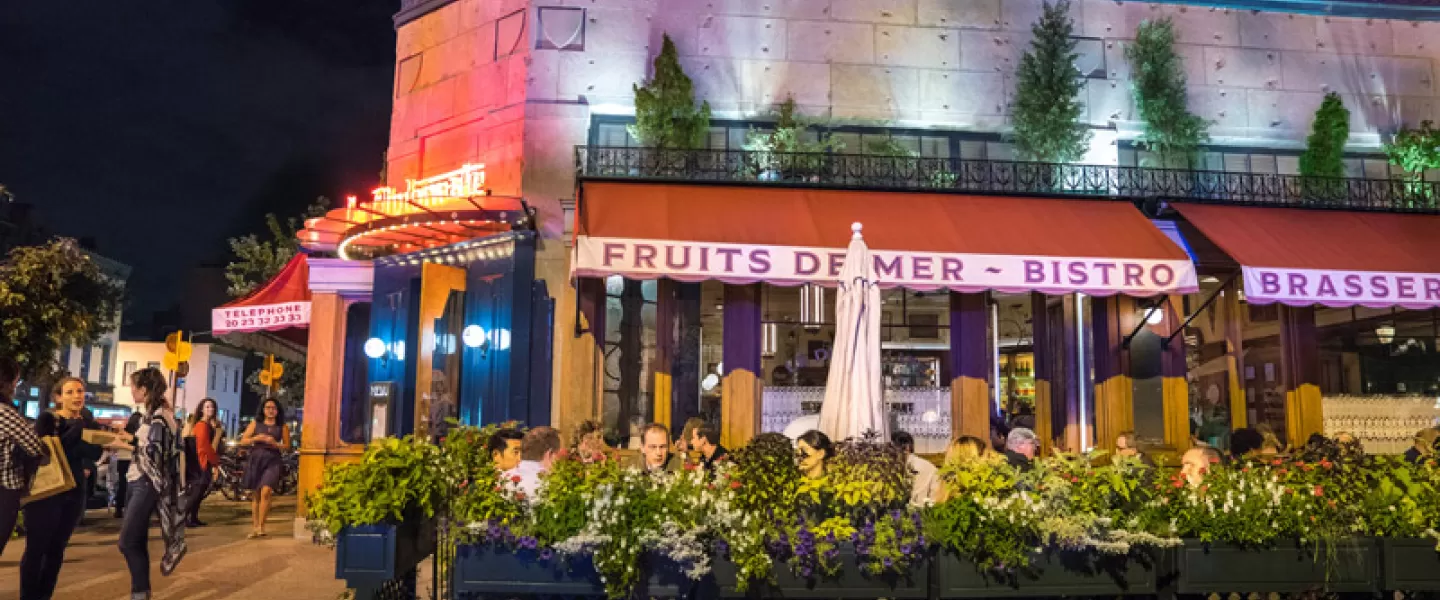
[554,278,605,440]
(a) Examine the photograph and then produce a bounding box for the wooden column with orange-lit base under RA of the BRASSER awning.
[1280,306,1325,447]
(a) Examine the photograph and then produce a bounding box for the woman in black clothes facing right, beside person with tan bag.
[20,377,131,600]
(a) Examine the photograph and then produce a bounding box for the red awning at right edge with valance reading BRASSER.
[1175,204,1440,308]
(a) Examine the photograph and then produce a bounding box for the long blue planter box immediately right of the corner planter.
[451,544,605,597]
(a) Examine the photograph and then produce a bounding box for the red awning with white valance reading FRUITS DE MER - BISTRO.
[573,181,1197,296]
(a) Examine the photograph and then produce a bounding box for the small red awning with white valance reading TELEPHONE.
[210,255,310,335]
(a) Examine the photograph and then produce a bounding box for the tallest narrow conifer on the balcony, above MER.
[1011,0,1090,163]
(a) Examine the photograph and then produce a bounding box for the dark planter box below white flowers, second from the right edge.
[1175,540,1380,594]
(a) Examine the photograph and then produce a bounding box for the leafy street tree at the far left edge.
[0,237,124,380]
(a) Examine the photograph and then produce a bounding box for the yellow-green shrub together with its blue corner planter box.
[307,436,444,599]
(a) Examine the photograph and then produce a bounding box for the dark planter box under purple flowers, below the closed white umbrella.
[749,544,930,600]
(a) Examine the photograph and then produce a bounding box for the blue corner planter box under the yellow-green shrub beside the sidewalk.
[336,518,435,599]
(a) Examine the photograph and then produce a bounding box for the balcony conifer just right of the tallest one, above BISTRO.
[1125,17,1210,168]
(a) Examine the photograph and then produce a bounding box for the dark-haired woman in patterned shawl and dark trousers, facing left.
[120,367,187,600]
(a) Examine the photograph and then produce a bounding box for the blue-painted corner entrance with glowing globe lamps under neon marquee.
[362,232,554,436]
